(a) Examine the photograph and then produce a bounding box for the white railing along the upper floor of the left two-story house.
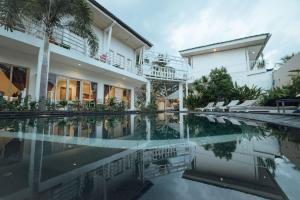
[8,20,142,75]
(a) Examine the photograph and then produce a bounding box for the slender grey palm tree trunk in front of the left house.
[39,33,50,111]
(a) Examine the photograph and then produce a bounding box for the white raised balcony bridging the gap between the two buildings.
[143,51,190,82]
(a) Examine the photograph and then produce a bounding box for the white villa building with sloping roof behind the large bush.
[179,33,272,90]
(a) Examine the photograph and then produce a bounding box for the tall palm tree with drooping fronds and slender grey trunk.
[0,0,98,110]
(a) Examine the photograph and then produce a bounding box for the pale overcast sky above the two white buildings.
[98,0,300,63]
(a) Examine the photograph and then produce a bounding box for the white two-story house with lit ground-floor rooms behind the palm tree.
[0,0,152,110]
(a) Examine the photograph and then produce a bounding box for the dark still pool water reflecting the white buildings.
[0,113,300,200]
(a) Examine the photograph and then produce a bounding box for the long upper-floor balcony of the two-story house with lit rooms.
[1,20,142,76]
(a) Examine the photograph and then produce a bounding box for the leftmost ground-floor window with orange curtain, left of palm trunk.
[0,63,29,100]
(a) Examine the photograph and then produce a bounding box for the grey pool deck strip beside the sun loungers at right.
[187,111,300,130]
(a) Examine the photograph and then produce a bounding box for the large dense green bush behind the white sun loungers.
[185,67,261,109]
